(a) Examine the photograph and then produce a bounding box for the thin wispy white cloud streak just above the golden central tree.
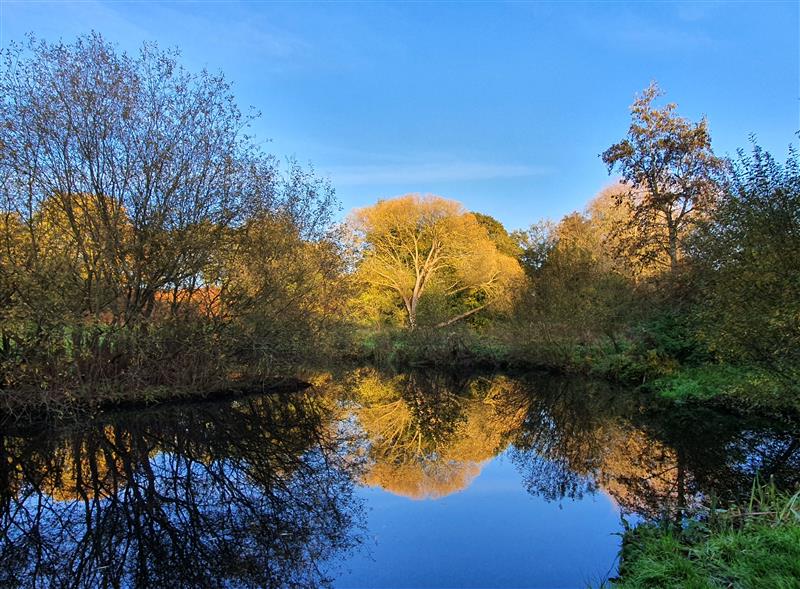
[328,161,550,188]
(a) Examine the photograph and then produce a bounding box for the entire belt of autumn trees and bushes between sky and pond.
[0,35,800,409]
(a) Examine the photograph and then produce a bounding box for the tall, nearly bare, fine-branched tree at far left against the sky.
[0,34,255,324]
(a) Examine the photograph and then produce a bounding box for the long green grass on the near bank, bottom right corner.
[612,481,800,589]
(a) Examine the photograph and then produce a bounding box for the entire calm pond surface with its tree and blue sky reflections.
[0,368,800,588]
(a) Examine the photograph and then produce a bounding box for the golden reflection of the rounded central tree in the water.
[350,369,527,499]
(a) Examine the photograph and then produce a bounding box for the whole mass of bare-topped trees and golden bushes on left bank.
[0,34,343,398]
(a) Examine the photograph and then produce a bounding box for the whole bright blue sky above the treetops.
[0,0,800,229]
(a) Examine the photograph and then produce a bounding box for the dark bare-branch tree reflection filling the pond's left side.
[0,394,361,587]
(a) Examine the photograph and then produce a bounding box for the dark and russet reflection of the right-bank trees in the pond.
[511,377,800,518]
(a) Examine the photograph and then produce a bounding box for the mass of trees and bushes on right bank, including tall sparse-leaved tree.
[497,85,800,411]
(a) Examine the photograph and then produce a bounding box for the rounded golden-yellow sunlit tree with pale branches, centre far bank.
[351,194,522,329]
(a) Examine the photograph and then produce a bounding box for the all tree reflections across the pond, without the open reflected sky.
[0,369,800,588]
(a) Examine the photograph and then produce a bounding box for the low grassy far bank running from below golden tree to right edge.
[354,327,800,417]
